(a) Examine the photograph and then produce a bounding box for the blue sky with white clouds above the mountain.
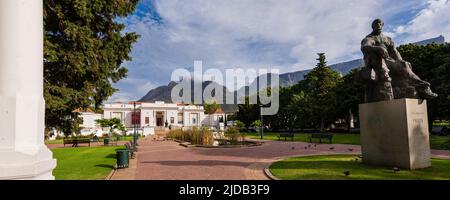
[110,0,450,101]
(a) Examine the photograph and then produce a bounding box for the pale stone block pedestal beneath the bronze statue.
[359,99,431,170]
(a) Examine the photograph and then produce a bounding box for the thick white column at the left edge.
[0,0,56,179]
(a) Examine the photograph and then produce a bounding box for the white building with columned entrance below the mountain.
[68,101,209,137]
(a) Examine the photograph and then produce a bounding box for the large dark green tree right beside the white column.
[44,0,138,134]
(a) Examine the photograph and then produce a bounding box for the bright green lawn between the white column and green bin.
[51,147,123,180]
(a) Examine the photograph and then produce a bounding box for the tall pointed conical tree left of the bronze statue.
[305,53,341,132]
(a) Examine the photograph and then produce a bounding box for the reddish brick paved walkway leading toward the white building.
[112,138,450,180]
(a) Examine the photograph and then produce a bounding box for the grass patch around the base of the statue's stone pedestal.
[269,155,450,180]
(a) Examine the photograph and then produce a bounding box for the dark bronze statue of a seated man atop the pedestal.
[361,19,437,102]
